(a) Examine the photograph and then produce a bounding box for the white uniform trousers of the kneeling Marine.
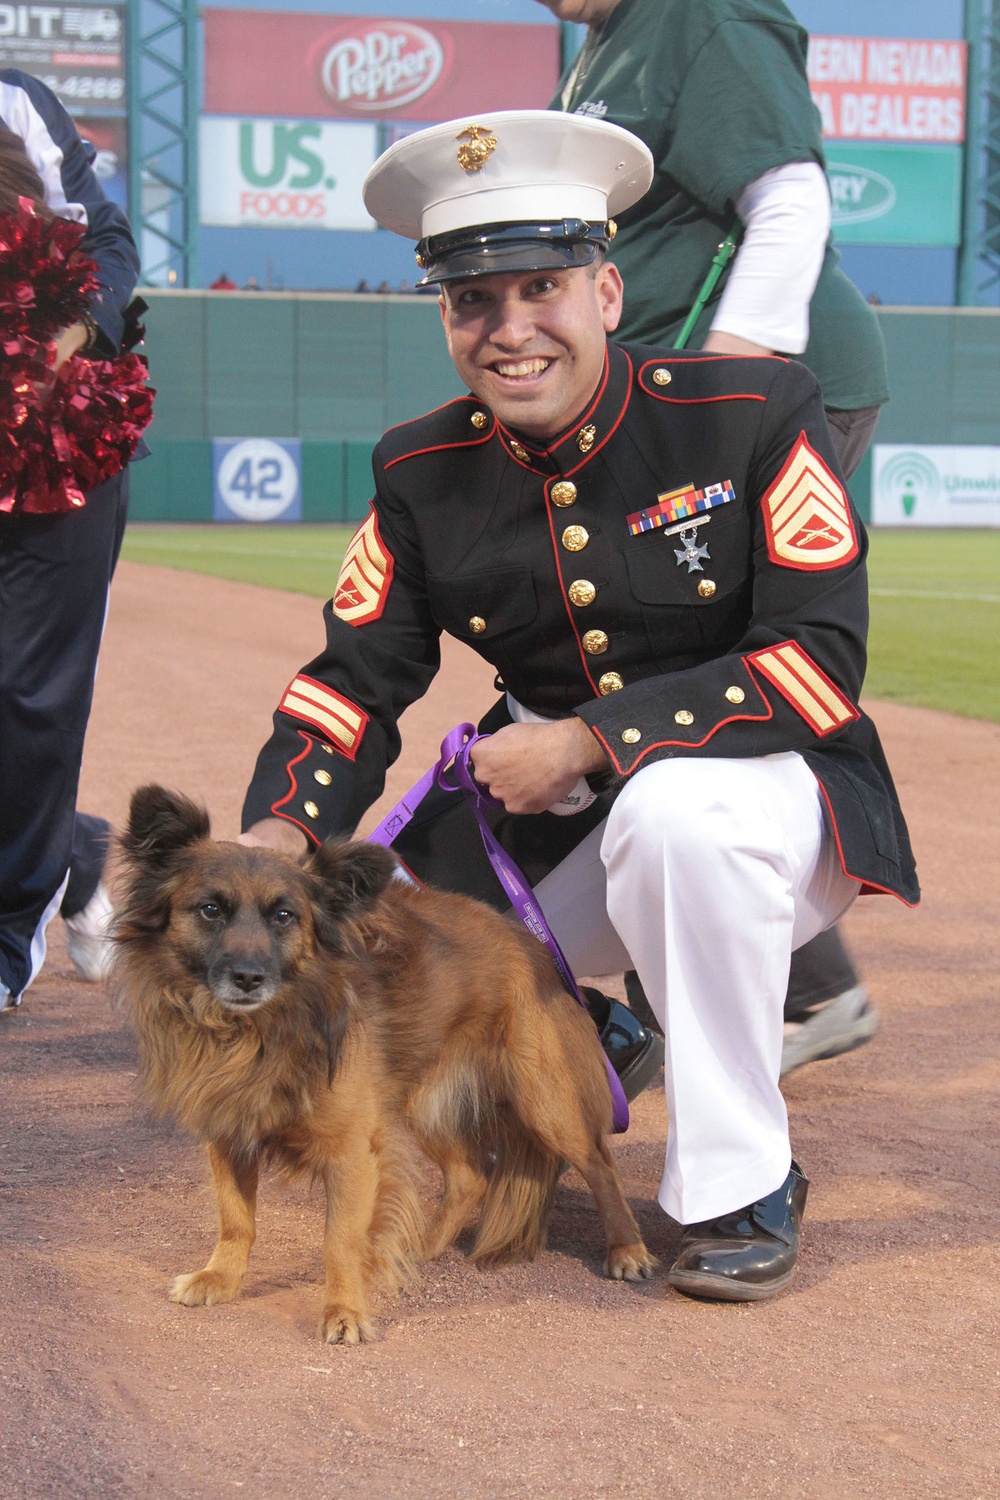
[535,753,858,1224]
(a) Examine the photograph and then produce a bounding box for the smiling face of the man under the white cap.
[441,261,622,443]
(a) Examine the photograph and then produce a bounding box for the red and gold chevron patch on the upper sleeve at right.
[762,432,858,572]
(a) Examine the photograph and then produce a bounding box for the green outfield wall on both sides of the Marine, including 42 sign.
[132,291,1000,524]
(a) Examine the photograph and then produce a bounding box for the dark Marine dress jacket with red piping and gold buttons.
[244,345,919,902]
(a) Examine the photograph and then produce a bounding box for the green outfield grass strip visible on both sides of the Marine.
[123,525,1000,723]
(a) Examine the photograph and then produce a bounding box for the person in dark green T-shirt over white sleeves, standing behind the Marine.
[540,0,889,1074]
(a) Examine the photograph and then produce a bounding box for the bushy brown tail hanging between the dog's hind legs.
[469,1116,562,1265]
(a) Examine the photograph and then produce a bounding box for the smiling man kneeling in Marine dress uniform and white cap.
[243,111,918,1301]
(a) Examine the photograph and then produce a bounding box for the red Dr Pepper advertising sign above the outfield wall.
[202,6,559,123]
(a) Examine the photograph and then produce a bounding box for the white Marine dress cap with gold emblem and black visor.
[363,110,652,285]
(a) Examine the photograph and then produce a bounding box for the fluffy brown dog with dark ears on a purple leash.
[115,786,654,1344]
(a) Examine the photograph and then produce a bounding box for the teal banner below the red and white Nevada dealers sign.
[825,141,963,245]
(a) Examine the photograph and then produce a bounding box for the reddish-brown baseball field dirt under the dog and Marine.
[0,564,1000,1500]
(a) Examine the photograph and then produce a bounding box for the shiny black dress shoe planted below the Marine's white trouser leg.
[667,1163,810,1302]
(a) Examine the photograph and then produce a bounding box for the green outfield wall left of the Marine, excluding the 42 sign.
[132,291,462,521]
